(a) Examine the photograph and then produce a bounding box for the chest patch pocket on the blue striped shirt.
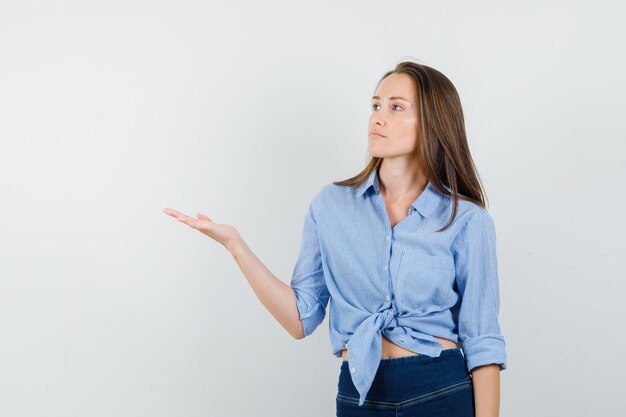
[394,249,455,314]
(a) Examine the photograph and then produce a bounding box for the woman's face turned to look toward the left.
[367,73,417,158]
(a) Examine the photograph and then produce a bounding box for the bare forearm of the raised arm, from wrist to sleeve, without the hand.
[228,238,304,339]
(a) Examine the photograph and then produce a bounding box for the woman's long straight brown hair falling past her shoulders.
[333,61,486,231]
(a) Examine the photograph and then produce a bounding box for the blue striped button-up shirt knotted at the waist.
[291,169,506,405]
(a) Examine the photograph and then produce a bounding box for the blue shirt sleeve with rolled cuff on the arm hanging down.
[452,207,506,372]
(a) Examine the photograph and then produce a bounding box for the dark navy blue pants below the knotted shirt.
[336,348,474,417]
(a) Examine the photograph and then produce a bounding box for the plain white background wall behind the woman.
[0,0,626,417]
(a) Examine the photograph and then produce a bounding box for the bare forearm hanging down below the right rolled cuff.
[472,364,500,417]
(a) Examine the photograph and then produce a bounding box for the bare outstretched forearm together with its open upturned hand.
[163,208,304,339]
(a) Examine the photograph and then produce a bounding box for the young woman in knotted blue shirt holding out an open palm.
[164,61,506,417]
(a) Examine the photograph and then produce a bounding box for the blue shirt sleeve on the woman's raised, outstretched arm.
[291,193,330,337]
